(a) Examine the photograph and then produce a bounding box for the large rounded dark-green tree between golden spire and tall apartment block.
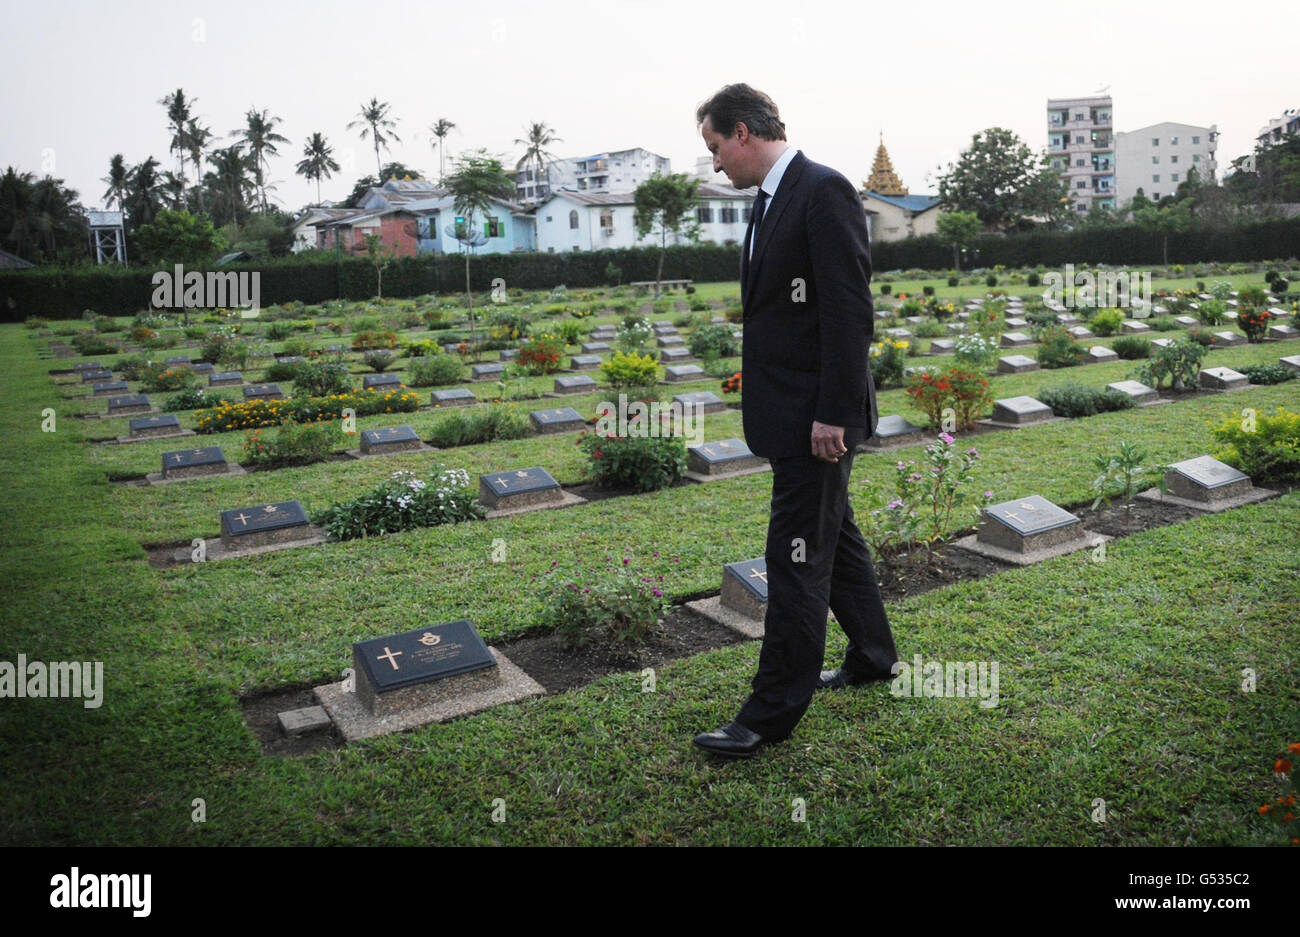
[939,127,1069,230]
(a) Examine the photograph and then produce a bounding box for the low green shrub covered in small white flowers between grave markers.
[312,465,488,541]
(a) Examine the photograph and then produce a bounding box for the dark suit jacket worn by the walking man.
[741,151,878,459]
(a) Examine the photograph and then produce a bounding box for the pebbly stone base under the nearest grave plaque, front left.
[312,647,546,742]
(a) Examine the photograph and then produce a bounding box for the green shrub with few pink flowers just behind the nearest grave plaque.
[536,556,670,648]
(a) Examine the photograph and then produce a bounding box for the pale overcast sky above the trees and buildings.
[0,0,1300,211]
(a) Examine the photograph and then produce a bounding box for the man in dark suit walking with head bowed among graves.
[696,84,898,758]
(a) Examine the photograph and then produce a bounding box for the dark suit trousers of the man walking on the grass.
[736,443,898,739]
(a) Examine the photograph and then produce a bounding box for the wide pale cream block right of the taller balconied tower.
[1115,121,1218,208]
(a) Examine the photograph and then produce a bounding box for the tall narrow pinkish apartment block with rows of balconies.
[1048,95,1115,212]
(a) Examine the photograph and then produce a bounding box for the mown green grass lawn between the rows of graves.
[0,283,1300,845]
